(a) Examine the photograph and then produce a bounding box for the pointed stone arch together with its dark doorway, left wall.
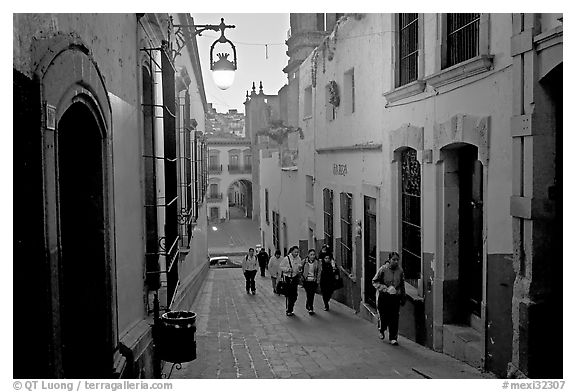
[32,33,118,378]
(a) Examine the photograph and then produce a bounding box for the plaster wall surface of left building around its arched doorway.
[13,14,207,378]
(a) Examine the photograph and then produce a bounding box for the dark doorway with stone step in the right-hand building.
[441,143,484,327]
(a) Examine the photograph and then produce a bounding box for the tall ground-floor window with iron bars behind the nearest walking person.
[401,148,421,287]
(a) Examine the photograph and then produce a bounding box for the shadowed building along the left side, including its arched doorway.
[13,14,208,378]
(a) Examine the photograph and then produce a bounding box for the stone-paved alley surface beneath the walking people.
[172,269,483,379]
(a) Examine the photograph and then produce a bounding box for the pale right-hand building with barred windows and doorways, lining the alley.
[260,14,563,377]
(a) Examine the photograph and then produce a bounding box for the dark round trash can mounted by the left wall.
[154,311,196,363]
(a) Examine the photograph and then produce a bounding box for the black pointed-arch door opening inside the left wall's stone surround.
[57,102,112,378]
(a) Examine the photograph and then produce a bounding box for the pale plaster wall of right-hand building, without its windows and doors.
[282,10,562,375]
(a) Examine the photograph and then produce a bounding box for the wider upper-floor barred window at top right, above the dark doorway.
[445,14,480,67]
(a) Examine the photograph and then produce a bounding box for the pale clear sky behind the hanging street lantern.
[191,13,290,113]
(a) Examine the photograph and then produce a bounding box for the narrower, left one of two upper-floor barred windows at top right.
[396,14,418,87]
